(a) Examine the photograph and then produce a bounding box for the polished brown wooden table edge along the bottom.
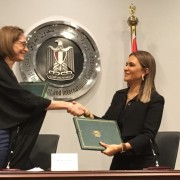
[0,170,180,180]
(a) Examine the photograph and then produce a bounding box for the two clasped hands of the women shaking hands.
[67,101,94,119]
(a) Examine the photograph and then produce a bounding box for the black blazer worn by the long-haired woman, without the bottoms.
[102,89,164,155]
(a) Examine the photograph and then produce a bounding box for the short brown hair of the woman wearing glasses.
[0,26,24,58]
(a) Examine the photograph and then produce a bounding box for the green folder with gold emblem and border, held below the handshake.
[73,117,122,151]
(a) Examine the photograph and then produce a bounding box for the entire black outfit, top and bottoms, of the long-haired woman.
[96,89,164,169]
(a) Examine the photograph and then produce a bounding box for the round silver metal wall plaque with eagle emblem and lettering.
[19,21,100,101]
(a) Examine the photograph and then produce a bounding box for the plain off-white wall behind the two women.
[0,0,180,170]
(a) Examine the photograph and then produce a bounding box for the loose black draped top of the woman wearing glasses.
[0,57,51,169]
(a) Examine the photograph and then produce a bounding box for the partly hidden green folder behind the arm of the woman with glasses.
[20,82,48,97]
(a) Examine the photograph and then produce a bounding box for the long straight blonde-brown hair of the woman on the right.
[129,51,156,103]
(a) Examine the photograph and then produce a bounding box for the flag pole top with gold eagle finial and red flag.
[127,4,139,52]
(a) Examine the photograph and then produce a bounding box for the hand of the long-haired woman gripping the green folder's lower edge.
[100,142,122,156]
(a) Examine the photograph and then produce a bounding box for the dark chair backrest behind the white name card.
[30,134,60,170]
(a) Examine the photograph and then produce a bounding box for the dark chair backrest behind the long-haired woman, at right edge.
[156,131,180,169]
